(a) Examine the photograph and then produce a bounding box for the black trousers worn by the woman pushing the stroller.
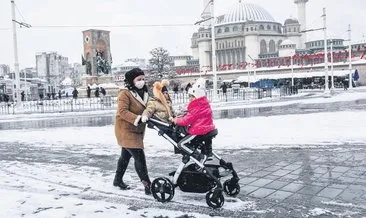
[116,148,151,183]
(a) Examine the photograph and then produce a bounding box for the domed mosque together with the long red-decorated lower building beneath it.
[179,0,366,86]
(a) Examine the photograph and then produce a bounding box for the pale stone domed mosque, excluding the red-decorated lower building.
[191,0,308,69]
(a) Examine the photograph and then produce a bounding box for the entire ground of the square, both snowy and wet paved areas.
[0,89,366,217]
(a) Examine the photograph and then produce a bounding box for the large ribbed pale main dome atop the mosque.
[219,1,276,24]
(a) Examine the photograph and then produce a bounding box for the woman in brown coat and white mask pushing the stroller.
[113,68,151,195]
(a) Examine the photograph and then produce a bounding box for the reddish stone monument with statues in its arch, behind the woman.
[83,29,112,76]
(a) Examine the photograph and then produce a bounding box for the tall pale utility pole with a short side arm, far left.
[10,0,31,107]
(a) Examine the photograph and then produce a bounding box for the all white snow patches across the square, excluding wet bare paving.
[0,89,366,217]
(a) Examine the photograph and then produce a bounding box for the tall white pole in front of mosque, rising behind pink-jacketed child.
[211,0,218,102]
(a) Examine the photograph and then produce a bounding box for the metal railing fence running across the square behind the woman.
[0,88,284,114]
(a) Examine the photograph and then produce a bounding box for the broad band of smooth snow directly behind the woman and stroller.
[0,111,366,154]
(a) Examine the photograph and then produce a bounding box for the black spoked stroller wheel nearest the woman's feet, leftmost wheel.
[151,177,174,203]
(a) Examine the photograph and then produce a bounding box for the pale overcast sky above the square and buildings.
[0,0,366,68]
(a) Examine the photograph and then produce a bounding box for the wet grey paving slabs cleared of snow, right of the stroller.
[217,145,366,217]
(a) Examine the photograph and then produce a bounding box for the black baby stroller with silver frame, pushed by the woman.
[147,117,240,208]
